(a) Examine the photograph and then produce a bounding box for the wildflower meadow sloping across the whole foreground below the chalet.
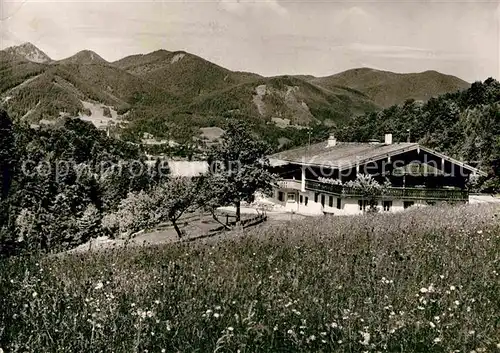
[0,205,500,353]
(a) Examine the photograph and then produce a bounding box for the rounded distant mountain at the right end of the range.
[310,68,470,107]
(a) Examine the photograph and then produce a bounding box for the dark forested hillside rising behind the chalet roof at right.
[337,78,500,190]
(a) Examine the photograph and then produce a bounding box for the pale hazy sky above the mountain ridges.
[0,0,500,82]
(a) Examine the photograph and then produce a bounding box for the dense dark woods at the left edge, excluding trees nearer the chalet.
[0,110,168,256]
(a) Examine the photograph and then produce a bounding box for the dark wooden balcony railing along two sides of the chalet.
[299,180,469,201]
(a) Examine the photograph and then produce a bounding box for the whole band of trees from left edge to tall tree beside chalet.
[0,110,274,256]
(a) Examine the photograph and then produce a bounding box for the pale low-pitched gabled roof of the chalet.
[269,141,484,175]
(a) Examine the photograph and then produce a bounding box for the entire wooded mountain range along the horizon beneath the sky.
[0,43,470,142]
